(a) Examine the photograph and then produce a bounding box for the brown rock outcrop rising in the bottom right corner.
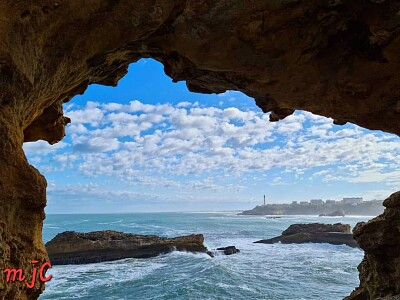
[345,192,400,300]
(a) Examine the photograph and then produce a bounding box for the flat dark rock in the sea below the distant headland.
[255,223,359,247]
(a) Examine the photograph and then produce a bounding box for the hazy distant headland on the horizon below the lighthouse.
[240,200,384,216]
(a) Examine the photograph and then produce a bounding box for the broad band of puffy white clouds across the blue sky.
[24,99,400,196]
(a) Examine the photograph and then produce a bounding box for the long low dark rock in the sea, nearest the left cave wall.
[46,230,207,265]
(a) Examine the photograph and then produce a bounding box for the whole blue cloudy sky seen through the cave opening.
[24,59,400,214]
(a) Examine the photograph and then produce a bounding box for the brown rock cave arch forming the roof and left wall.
[0,0,400,299]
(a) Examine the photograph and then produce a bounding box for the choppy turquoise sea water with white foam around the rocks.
[40,213,370,300]
